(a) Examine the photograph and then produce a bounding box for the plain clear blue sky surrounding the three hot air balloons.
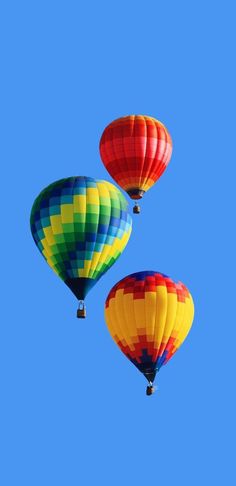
[0,0,236,486]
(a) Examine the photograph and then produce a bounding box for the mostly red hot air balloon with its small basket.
[100,115,172,213]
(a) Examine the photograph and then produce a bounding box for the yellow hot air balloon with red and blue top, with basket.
[105,271,194,395]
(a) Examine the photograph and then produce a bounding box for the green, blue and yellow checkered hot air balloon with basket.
[30,177,132,317]
